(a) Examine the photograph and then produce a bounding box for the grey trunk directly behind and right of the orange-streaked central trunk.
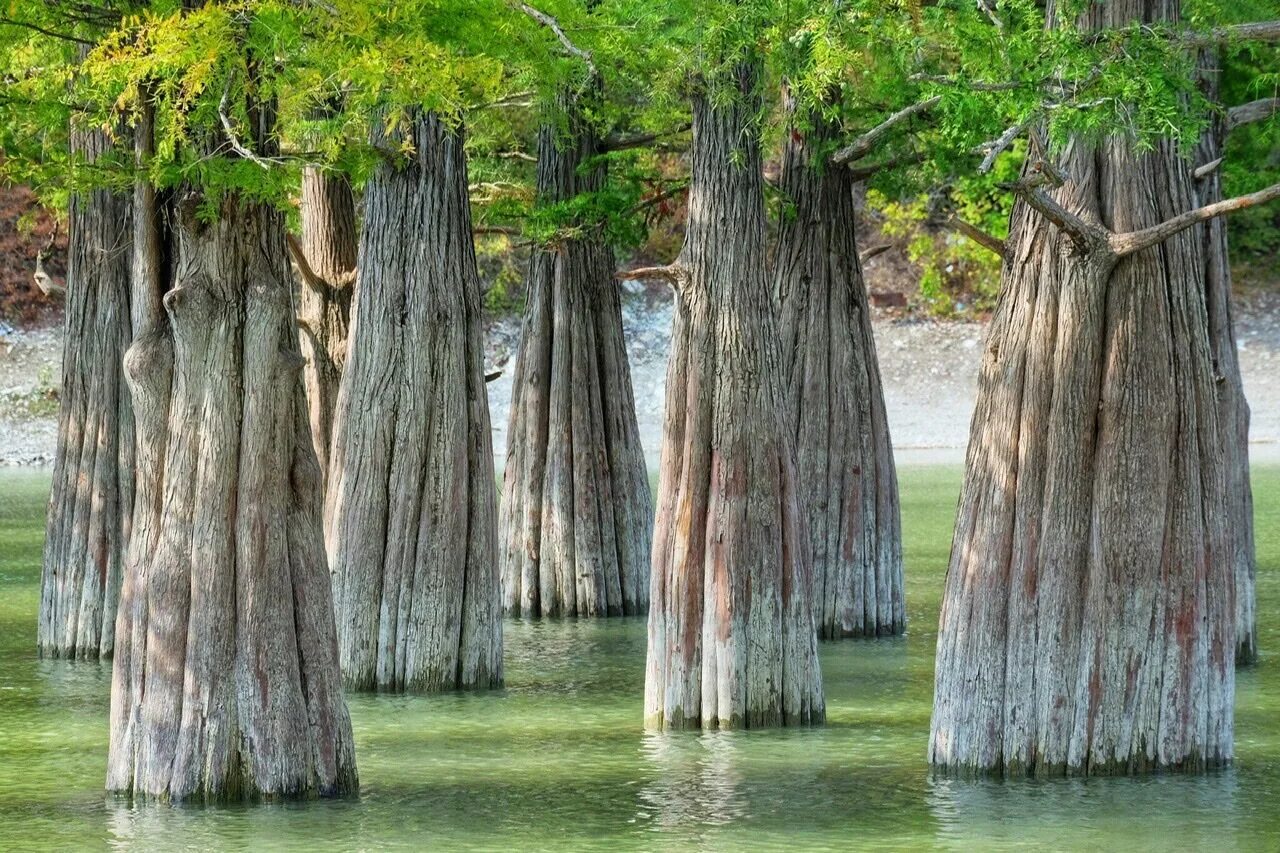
[774,106,906,639]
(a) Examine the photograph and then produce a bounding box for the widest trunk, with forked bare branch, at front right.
[929,0,1235,775]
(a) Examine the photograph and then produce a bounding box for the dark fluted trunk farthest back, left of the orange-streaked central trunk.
[500,97,653,616]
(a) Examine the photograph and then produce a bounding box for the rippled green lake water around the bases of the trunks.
[0,469,1280,850]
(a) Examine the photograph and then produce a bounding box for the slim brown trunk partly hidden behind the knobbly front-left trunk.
[298,168,357,484]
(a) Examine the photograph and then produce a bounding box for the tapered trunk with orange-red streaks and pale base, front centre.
[645,65,824,727]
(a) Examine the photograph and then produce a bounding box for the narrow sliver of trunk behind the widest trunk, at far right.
[1196,51,1258,663]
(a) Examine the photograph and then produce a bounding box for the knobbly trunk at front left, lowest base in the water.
[108,97,357,800]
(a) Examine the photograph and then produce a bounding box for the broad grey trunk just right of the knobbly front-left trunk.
[325,115,502,690]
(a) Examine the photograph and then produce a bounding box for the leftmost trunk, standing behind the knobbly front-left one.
[37,119,133,658]
